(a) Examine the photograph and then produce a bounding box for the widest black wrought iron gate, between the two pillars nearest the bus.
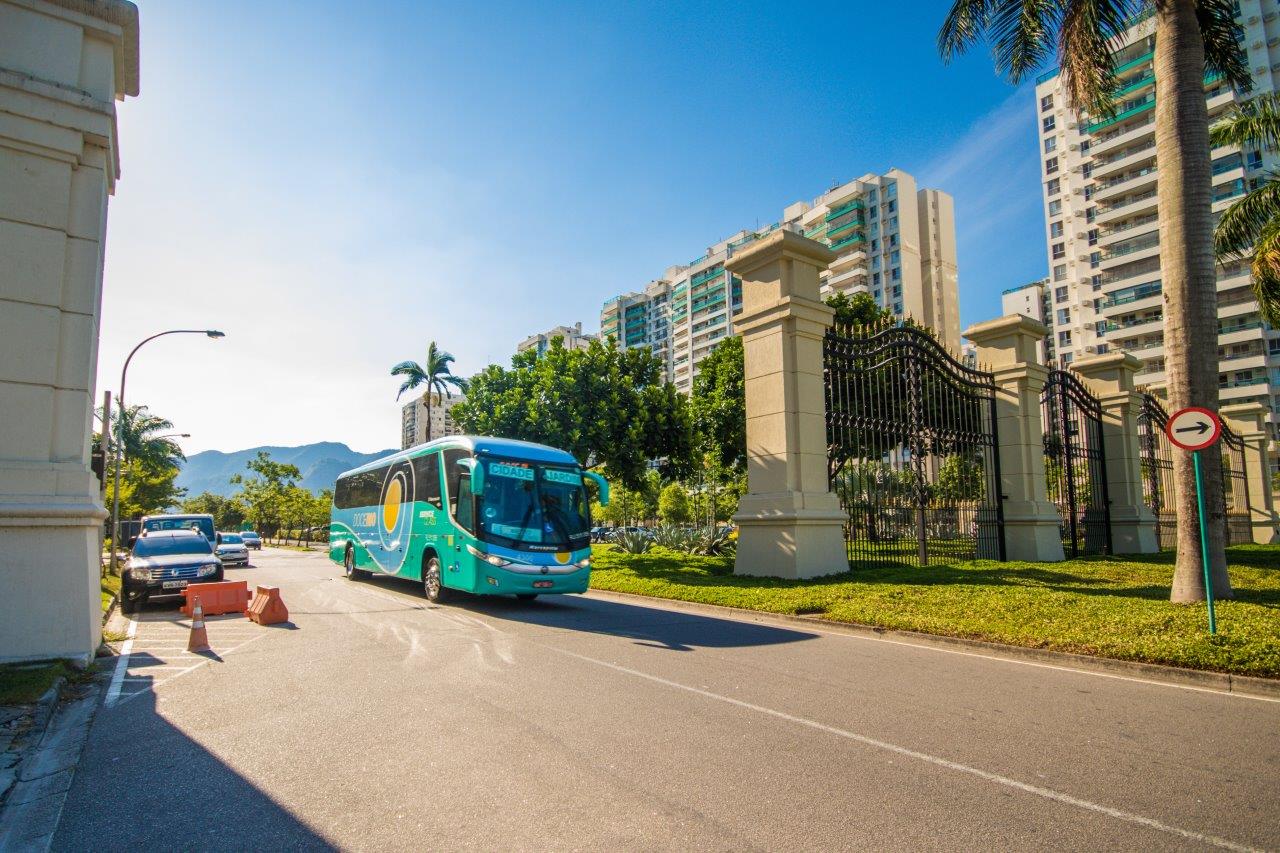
[823,323,1005,566]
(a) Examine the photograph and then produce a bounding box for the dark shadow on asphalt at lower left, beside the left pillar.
[51,679,340,852]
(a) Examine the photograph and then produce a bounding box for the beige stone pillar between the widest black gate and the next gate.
[964,314,1064,561]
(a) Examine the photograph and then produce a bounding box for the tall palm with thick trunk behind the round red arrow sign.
[938,0,1252,601]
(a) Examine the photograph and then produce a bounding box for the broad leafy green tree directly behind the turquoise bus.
[453,341,692,489]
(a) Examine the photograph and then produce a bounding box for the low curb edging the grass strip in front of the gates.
[588,589,1280,701]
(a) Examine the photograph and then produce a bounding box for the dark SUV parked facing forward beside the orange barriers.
[120,530,224,613]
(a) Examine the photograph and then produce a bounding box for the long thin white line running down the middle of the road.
[558,643,1261,853]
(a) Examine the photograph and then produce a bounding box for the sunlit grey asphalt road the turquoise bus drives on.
[54,549,1280,850]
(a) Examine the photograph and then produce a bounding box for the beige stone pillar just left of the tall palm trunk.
[1071,352,1160,553]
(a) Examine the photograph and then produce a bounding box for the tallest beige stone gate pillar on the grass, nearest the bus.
[724,231,849,578]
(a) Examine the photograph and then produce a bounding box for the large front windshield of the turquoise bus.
[477,460,591,551]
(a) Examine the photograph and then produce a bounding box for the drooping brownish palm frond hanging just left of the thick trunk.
[1057,0,1137,118]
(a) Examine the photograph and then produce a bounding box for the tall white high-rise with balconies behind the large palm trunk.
[1036,0,1280,407]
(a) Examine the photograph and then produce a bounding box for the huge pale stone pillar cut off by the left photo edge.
[0,0,138,660]
